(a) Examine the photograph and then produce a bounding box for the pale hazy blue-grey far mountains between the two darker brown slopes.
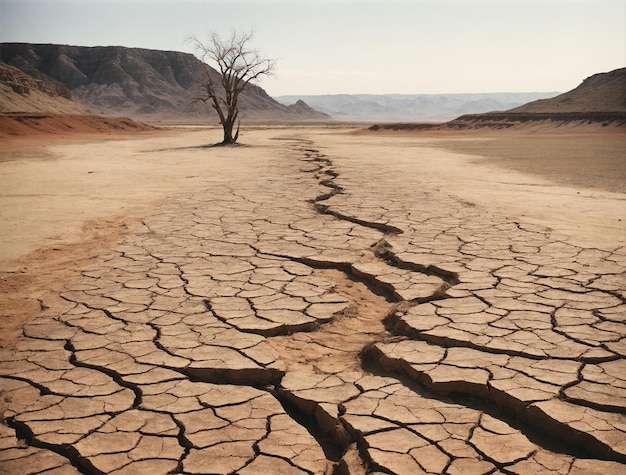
[275,92,558,122]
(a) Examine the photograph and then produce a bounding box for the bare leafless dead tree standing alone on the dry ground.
[189,31,276,145]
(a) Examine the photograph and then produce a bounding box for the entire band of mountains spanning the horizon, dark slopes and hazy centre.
[0,43,626,123]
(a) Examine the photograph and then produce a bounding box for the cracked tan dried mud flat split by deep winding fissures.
[0,128,626,474]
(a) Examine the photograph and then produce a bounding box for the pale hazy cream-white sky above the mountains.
[0,0,626,96]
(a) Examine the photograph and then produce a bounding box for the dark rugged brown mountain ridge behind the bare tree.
[0,43,330,121]
